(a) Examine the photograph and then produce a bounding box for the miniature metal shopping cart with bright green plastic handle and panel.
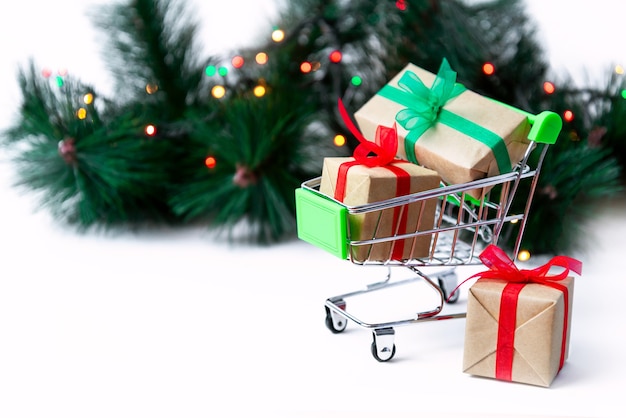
[296,109,562,362]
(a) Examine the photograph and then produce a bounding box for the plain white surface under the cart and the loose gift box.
[0,1,626,418]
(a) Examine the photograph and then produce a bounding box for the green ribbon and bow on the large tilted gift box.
[378,58,511,174]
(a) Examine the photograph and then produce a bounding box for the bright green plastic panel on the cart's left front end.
[296,188,348,260]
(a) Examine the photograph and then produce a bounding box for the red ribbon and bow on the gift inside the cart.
[334,99,411,260]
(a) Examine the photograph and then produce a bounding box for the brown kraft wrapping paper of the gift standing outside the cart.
[463,277,574,387]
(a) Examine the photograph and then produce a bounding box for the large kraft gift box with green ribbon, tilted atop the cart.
[354,59,531,197]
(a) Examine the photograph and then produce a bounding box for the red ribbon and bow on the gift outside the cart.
[452,244,582,381]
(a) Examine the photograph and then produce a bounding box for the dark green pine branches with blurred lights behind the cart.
[3,0,626,253]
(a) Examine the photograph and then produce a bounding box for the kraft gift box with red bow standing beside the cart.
[463,245,582,387]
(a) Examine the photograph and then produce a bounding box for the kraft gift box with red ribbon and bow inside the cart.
[320,100,441,262]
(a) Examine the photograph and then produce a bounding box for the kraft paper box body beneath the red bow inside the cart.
[320,157,441,262]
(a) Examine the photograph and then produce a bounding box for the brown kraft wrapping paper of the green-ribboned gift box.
[354,64,530,197]
